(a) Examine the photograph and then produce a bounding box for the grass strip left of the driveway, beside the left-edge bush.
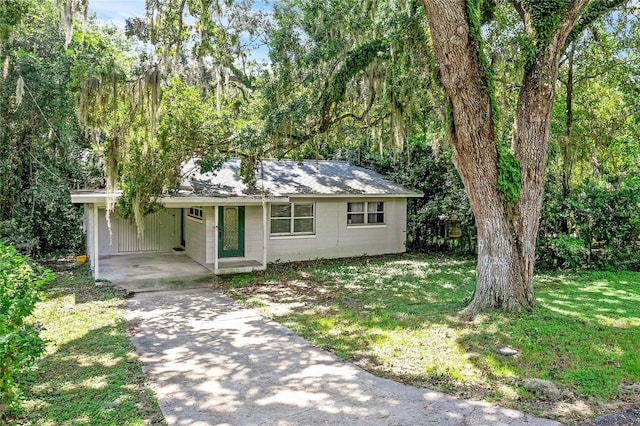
[14,263,166,425]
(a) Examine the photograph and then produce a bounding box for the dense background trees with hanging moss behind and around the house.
[0,0,640,269]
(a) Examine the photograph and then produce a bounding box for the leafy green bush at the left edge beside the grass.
[0,239,53,419]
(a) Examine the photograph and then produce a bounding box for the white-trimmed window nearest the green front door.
[271,203,316,235]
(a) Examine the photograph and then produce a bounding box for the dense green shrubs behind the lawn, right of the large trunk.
[538,175,640,270]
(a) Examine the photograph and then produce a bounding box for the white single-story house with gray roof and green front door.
[71,159,422,278]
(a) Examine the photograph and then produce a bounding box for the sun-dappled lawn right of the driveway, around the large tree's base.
[219,254,640,422]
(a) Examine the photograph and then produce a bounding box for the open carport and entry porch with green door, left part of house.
[71,190,272,282]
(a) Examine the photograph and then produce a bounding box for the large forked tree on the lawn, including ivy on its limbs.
[423,0,625,315]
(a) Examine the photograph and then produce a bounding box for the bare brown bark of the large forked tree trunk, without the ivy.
[423,0,585,316]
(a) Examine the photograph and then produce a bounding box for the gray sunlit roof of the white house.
[180,159,420,197]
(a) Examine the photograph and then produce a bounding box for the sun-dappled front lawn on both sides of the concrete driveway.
[8,254,640,425]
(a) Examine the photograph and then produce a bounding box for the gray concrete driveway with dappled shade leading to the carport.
[129,289,558,425]
